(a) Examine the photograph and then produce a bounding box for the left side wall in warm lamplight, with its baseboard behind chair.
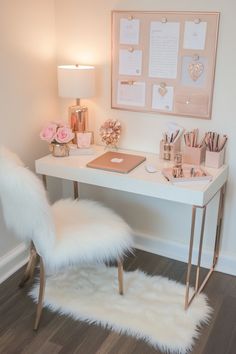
[0,0,60,282]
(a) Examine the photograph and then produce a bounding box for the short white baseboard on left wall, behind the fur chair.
[0,243,29,284]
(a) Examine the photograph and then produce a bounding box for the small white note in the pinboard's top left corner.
[120,18,139,44]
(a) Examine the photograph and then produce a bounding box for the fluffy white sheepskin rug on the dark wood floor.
[30,265,212,353]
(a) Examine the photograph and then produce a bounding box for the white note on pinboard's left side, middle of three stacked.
[119,49,142,75]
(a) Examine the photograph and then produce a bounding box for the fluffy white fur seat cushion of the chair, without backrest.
[52,199,131,264]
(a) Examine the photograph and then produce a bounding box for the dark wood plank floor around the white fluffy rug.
[0,251,236,354]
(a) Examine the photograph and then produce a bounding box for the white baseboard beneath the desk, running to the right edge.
[134,233,236,275]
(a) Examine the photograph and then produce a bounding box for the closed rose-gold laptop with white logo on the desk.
[87,151,146,173]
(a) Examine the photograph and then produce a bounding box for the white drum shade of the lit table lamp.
[57,65,95,98]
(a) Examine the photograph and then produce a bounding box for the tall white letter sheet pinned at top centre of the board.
[149,21,180,79]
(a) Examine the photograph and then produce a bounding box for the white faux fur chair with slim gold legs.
[0,148,132,329]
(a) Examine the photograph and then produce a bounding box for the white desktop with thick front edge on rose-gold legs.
[35,146,228,206]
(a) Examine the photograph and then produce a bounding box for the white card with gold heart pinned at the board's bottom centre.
[152,85,174,111]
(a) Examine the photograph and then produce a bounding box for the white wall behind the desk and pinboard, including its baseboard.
[55,0,236,274]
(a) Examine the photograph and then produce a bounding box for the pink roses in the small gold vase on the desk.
[40,122,75,144]
